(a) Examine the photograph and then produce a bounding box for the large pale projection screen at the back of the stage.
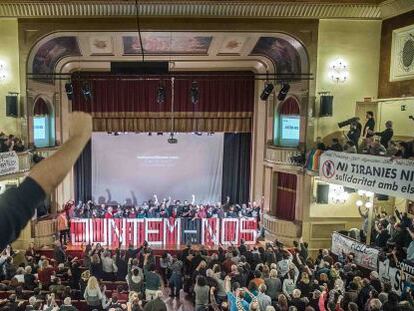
[92,133,223,204]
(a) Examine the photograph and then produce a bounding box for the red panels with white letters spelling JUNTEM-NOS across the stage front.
[71,218,257,248]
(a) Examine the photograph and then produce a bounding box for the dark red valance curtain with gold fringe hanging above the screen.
[72,72,254,132]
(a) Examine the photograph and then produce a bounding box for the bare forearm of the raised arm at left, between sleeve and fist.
[29,134,90,193]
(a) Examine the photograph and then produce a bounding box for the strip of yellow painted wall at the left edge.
[0,18,20,136]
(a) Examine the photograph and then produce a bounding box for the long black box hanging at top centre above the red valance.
[111,62,168,74]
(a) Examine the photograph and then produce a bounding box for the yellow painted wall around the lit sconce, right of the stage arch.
[315,19,381,137]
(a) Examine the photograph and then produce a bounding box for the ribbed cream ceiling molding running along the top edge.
[0,0,384,19]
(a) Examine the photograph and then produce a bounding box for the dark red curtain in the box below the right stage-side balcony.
[276,173,297,221]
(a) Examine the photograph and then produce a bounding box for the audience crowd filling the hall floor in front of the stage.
[0,236,414,311]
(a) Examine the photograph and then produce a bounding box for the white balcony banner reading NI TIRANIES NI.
[319,151,414,200]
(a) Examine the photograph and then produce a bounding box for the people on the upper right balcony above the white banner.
[316,111,414,159]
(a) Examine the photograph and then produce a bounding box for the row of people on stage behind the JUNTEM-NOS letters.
[65,195,261,220]
